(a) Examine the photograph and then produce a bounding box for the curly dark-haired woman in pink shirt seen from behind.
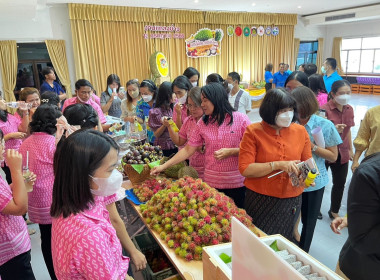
[20,104,62,279]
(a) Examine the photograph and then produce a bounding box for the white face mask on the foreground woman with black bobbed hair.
[90,169,123,196]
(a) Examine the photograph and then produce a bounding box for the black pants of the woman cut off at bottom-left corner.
[0,250,36,280]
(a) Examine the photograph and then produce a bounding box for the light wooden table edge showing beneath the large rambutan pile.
[121,181,266,280]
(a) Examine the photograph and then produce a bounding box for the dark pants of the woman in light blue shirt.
[300,187,325,252]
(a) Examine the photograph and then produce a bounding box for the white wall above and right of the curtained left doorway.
[0,4,75,94]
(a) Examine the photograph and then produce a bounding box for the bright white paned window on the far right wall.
[341,37,380,74]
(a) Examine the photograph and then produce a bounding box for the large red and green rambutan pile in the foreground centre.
[140,177,253,261]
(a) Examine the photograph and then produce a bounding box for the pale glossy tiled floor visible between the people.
[30,94,380,280]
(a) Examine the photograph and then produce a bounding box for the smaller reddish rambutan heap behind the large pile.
[133,178,172,202]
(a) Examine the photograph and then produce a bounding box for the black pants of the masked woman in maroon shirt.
[326,154,348,213]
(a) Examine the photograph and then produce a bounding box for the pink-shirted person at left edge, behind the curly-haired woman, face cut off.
[0,103,29,184]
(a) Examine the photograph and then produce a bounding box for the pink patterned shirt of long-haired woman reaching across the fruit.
[188,112,250,189]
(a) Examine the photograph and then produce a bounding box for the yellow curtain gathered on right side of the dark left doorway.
[45,40,72,97]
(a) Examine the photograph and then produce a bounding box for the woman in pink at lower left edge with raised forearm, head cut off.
[0,133,35,280]
